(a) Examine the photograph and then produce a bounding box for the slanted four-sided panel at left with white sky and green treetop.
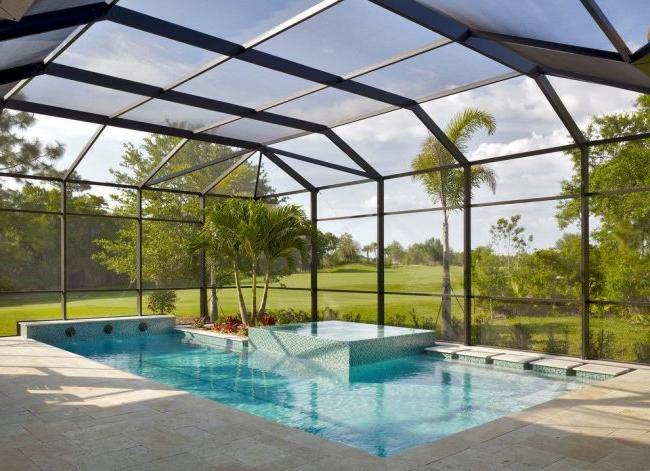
[75,127,178,184]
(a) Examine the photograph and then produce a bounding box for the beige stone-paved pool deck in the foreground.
[0,337,650,471]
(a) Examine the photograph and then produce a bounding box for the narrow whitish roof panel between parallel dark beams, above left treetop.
[120,99,234,131]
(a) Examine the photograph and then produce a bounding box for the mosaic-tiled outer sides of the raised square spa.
[248,322,435,369]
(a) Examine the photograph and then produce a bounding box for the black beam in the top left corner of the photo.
[0,2,111,41]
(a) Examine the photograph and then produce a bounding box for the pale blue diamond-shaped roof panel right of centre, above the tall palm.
[354,43,512,100]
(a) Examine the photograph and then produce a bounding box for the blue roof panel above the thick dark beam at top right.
[418,0,613,50]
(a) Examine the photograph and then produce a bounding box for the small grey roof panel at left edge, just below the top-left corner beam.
[0,28,74,69]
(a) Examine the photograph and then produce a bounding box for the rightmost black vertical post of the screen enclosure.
[580,147,590,358]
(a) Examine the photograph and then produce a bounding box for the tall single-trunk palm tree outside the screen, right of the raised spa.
[411,108,496,338]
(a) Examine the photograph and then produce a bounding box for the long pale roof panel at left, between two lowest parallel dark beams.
[20,75,142,116]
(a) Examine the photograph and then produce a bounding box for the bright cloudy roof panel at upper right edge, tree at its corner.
[549,77,648,137]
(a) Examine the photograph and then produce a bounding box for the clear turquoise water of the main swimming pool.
[58,334,581,456]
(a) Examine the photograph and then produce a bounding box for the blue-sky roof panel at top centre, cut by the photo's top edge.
[258,0,440,75]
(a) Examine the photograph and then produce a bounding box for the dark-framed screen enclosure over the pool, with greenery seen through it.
[0,0,650,363]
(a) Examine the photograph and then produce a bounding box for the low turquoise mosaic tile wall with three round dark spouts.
[20,316,176,343]
